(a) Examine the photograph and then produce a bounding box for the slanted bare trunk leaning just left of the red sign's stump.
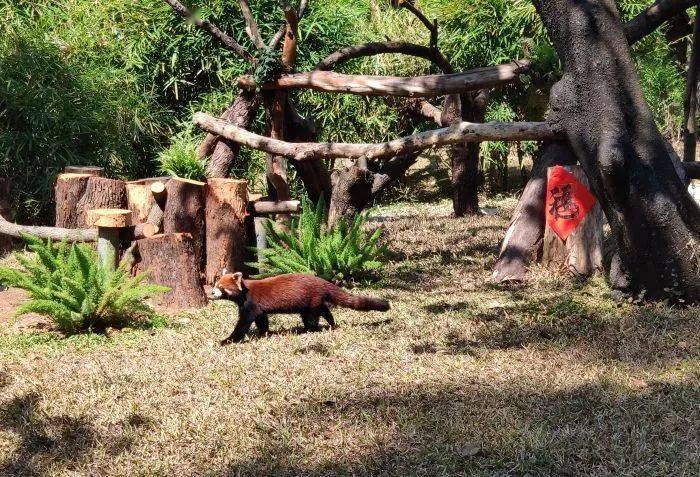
[492,142,576,283]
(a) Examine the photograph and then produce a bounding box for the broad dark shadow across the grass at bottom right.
[217,379,700,476]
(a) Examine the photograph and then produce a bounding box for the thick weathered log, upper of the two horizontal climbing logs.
[238,60,530,97]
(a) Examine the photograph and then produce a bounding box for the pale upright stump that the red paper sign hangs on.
[542,166,605,278]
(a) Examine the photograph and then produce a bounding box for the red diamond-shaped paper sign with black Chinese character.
[546,166,596,240]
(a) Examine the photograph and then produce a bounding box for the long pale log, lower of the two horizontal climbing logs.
[194,113,559,161]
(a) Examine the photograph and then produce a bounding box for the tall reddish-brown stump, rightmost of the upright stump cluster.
[205,178,248,284]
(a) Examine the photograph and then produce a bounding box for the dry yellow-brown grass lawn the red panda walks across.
[0,199,700,476]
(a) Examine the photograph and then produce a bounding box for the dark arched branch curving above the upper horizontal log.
[314,41,454,74]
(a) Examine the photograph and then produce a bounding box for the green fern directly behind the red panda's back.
[250,198,386,284]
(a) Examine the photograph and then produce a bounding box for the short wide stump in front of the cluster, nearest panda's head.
[136,233,207,309]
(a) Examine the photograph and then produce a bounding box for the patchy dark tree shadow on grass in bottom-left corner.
[0,380,152,477]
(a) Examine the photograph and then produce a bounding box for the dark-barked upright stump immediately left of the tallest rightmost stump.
[163,177,205,271]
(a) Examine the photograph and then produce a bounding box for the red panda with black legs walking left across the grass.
[211,270,389,345]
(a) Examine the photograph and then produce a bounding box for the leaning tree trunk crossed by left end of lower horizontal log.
[198,90,260,177]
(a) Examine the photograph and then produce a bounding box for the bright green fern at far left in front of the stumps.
[0,235,168,333]
